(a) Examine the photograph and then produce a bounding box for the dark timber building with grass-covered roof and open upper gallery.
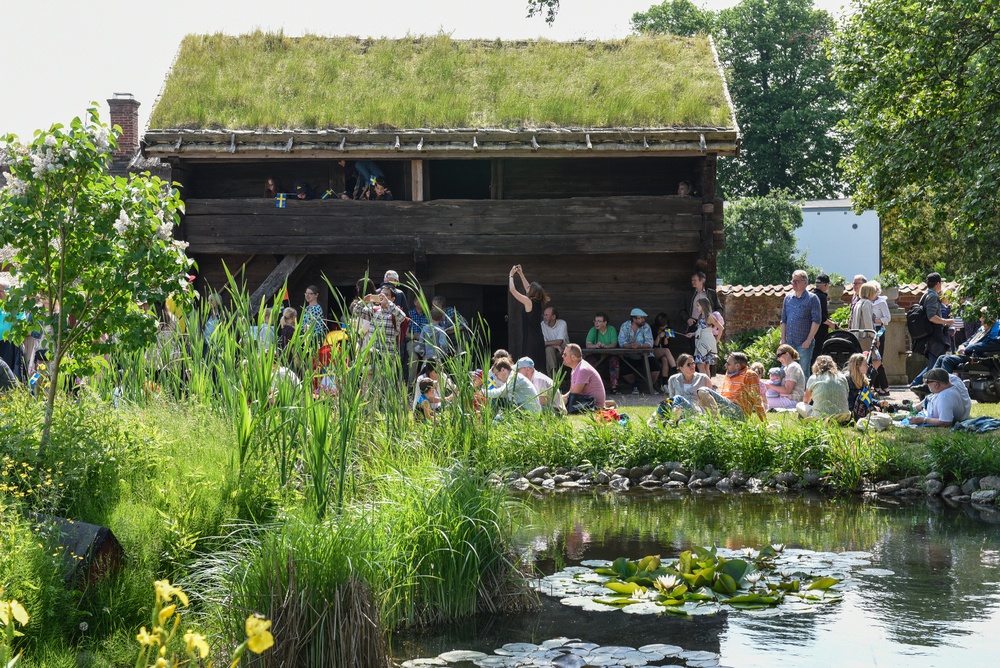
[142,33,739,346]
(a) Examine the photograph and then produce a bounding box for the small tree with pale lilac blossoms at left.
[0,108,191,453]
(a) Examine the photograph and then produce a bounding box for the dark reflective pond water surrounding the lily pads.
[393,491,1000,667]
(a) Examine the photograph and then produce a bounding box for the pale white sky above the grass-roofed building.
[0,0,846,139]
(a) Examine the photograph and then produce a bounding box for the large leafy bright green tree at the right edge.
[832,0,1000,316]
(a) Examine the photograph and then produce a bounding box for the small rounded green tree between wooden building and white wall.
[719,191,802,285]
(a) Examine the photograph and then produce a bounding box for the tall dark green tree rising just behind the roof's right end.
[714,0,844,199]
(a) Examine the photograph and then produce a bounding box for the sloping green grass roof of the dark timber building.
[150,32,734,130]
